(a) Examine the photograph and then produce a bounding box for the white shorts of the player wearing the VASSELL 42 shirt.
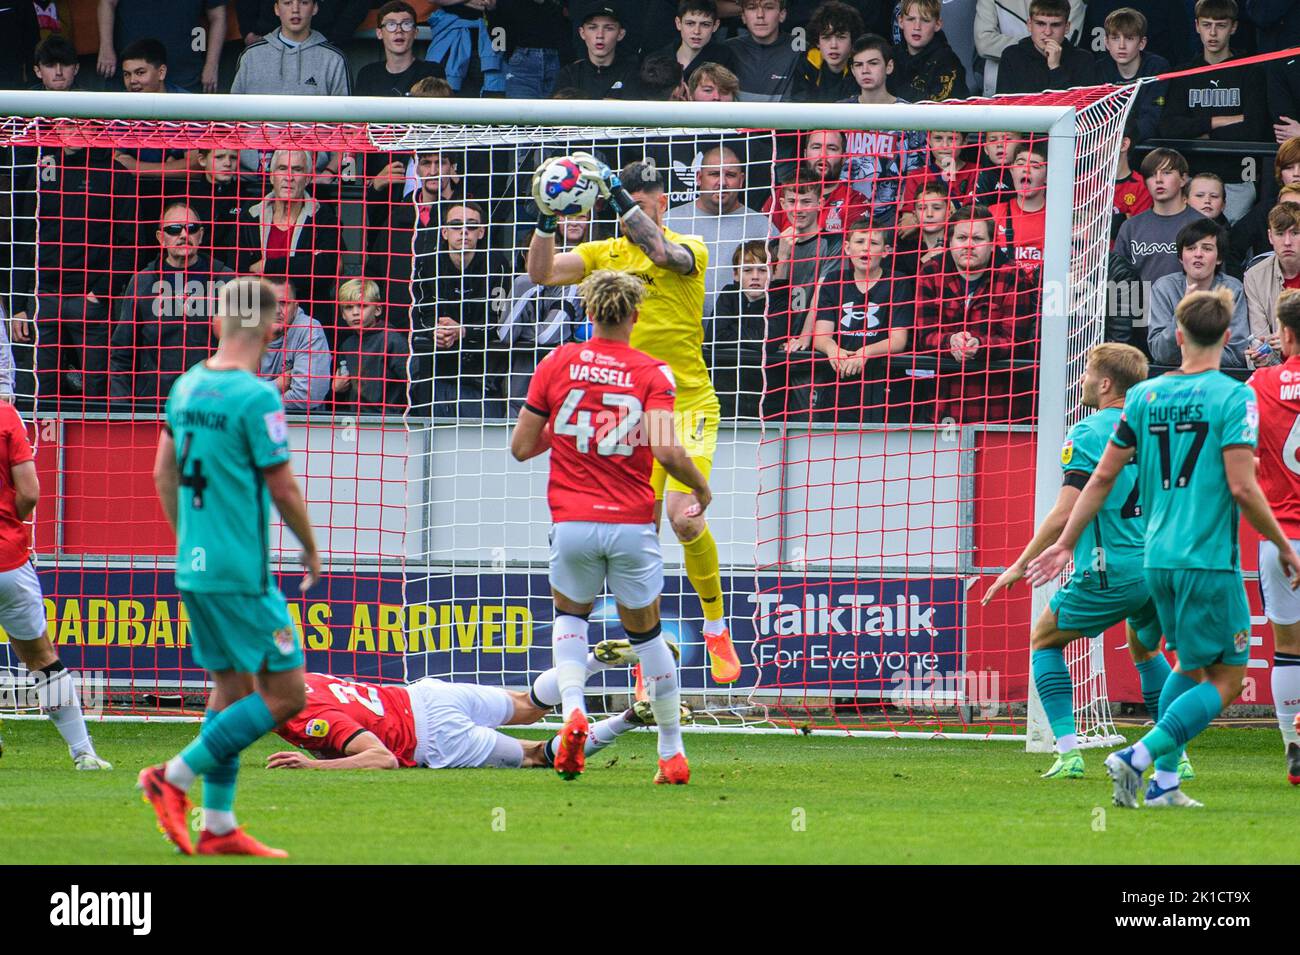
[551,521,663,611]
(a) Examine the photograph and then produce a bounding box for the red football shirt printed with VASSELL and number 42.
[527,338,676,524]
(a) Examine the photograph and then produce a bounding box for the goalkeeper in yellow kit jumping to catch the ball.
[528,153,740,683]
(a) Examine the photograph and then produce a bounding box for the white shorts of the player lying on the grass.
[407,677,523,769]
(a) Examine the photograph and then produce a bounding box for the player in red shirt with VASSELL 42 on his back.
[510,269,711,783]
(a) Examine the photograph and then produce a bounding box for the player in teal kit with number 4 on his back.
[139,278,320,858]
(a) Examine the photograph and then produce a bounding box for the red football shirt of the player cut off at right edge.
[1247,357,1300,541]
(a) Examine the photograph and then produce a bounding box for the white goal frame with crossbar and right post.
[0,91,1086,751]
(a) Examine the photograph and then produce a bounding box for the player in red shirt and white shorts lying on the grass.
[267,641,691,769]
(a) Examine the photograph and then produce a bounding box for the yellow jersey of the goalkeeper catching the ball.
[573,229,718,412]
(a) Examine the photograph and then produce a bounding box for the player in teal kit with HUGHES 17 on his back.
[1028,290,1300,808]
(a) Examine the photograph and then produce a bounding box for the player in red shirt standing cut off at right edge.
[1247,288,1300,786]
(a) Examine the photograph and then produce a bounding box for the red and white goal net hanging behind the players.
[0,88,1132,745]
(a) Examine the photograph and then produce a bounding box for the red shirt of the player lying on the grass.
[276,673,416,767]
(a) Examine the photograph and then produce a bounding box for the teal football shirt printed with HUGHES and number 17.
[1112,372,1260,570]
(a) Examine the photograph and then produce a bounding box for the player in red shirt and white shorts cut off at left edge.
[0,401,113,769]
